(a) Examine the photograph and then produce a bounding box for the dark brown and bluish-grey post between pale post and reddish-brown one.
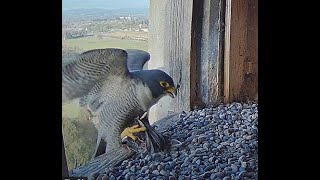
[190,0,224,106]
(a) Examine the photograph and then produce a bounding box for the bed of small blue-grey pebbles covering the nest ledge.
[94,103,258,180]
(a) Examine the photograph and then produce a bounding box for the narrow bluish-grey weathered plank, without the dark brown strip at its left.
[200,0,224,105]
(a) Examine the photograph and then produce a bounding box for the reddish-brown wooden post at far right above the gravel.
[224,0,258,103]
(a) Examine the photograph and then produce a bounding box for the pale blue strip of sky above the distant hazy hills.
[62,0,149,10]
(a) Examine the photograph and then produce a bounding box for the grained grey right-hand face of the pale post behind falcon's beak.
[164,0,195,112]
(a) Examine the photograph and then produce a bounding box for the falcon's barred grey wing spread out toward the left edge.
[62,48,129,102]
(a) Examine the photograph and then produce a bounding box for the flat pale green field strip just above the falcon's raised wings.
[62,36,148,51]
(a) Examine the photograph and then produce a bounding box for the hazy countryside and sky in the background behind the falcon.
[62,0,149,169]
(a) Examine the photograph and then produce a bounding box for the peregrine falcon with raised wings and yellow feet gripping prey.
[62,48,176,164]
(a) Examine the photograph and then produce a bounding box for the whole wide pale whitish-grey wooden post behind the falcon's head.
[148,0,194,123]
